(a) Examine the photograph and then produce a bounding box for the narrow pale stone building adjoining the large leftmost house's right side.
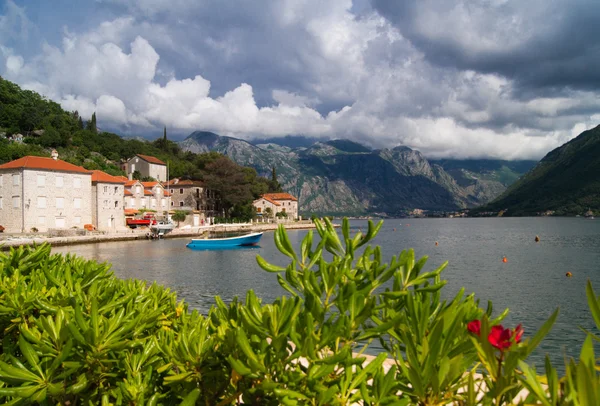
[92,171,126,231]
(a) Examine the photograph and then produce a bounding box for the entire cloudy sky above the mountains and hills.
[0,0,600,159]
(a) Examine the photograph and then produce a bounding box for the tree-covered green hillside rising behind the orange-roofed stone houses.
[0,77,279,218]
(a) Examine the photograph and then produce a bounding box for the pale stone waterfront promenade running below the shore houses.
[0,220,315,250]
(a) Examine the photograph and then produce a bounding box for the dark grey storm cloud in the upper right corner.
[373,0,600,93]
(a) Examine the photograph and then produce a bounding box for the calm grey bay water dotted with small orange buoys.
[53,217,600,369]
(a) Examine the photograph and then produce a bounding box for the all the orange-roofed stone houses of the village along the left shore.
[0,150,299,233]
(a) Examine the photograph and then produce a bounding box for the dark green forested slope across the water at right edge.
[477,126,600,216]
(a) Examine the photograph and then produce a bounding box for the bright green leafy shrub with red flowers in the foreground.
[0,220,600,405]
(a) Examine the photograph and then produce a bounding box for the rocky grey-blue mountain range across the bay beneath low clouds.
[179,131,536,216]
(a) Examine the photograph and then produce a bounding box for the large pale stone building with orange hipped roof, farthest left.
[0,155,92,232]
